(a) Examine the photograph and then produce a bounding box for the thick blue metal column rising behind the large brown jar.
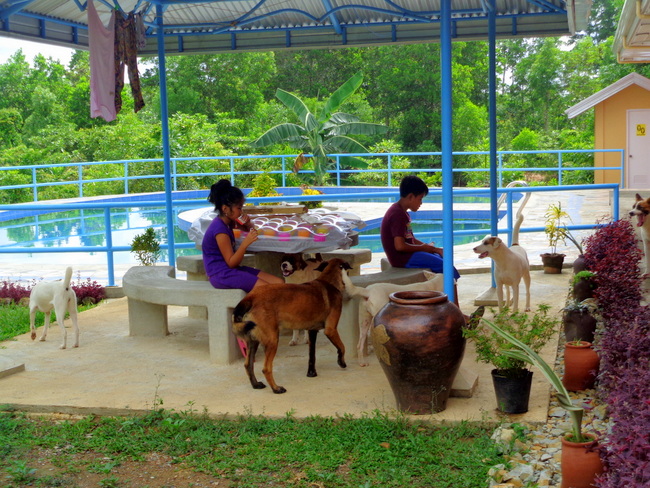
[440,0,455,302]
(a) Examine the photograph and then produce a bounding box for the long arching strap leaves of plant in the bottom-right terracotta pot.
[484,320,587,442]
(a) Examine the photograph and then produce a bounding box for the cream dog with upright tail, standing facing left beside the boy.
[474,215,530,312]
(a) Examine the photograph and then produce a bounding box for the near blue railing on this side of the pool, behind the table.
[0,184,619,285]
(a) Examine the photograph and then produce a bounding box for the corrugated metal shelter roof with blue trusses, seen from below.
[0,0,591,54]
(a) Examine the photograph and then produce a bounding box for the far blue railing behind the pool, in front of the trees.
[0,149,625,202]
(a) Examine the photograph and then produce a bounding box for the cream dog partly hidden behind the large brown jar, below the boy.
[343,271,443,366]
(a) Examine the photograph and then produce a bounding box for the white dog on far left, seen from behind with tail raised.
[29,267,79,349]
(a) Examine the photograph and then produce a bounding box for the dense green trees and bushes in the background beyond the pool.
[0,0,636,198]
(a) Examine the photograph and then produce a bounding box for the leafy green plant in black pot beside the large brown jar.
[463,304,558,413]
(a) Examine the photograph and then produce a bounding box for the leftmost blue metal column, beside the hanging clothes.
[156,4,176,266]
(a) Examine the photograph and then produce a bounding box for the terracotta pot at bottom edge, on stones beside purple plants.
[561,434,603,488]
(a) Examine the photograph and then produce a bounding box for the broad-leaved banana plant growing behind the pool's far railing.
[251,73,388,185]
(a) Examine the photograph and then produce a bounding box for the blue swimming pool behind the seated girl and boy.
[0,188,502,267]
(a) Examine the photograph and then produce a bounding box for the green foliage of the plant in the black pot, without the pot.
[463,304,558,376]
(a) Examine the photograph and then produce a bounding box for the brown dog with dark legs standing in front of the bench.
[232,258,350,393]
